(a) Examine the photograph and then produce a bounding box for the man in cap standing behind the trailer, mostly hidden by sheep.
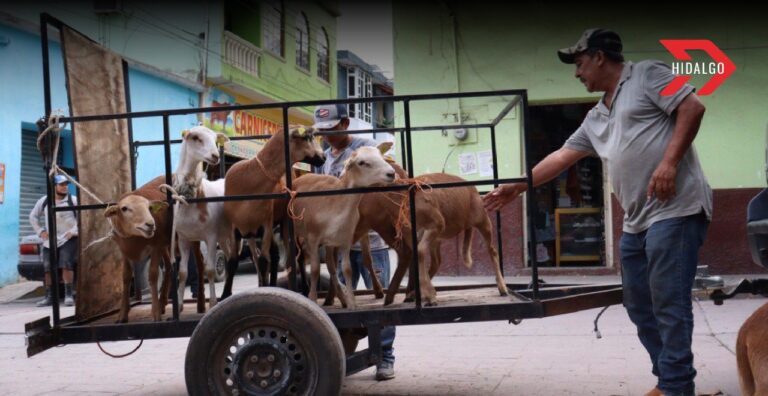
[313,104,395,381]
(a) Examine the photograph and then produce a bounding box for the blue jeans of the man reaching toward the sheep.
[621,213,709,396]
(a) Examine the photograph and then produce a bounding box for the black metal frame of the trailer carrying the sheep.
[27,14,621,360]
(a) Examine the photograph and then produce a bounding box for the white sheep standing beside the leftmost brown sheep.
[173,126,235,311]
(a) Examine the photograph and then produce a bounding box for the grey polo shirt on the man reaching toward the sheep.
[563,61,712,234]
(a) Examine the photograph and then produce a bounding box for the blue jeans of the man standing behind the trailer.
[337,249,395,363]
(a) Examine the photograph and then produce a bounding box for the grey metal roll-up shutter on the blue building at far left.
[19,130,45,239]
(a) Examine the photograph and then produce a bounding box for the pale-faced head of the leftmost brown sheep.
[104,195,168,239]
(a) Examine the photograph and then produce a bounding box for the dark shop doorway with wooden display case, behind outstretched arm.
[529,103,606,267]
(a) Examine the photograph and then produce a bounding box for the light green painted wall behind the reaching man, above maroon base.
[393,1,768,188]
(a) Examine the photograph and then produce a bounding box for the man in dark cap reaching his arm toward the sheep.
[484,29,712,396]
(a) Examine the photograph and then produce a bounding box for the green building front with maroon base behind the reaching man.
[393,1,768,276]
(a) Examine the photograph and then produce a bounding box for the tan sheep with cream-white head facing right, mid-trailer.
[293,147,395,308]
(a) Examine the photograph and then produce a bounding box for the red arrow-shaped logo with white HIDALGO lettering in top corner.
[659,40,736,96]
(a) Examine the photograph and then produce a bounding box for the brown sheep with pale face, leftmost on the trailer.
[104,176,171,323]
